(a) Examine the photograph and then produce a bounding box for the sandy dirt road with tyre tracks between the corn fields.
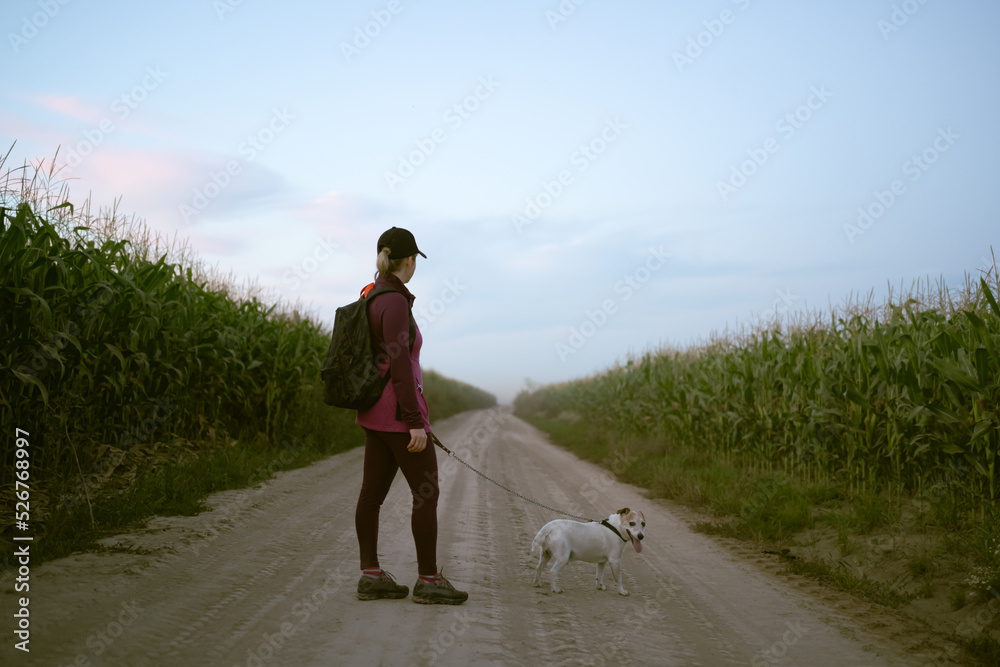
[0,411,952,667]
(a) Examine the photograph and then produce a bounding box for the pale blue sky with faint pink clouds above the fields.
[0,0,1000,402]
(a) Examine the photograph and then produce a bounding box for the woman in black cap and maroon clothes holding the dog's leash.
[354,227,469,604]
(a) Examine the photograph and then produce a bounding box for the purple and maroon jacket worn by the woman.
[354,274,431,433]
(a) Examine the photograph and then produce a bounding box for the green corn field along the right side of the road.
[515,267,1000,518]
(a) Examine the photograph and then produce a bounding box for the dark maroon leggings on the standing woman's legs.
[354,428,438,575]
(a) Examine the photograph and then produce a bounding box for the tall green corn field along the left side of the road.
[0,156,496,526]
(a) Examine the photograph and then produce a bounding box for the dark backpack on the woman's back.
[319,285,416,410]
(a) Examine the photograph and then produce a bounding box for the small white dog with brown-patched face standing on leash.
[531,507,646,595]
